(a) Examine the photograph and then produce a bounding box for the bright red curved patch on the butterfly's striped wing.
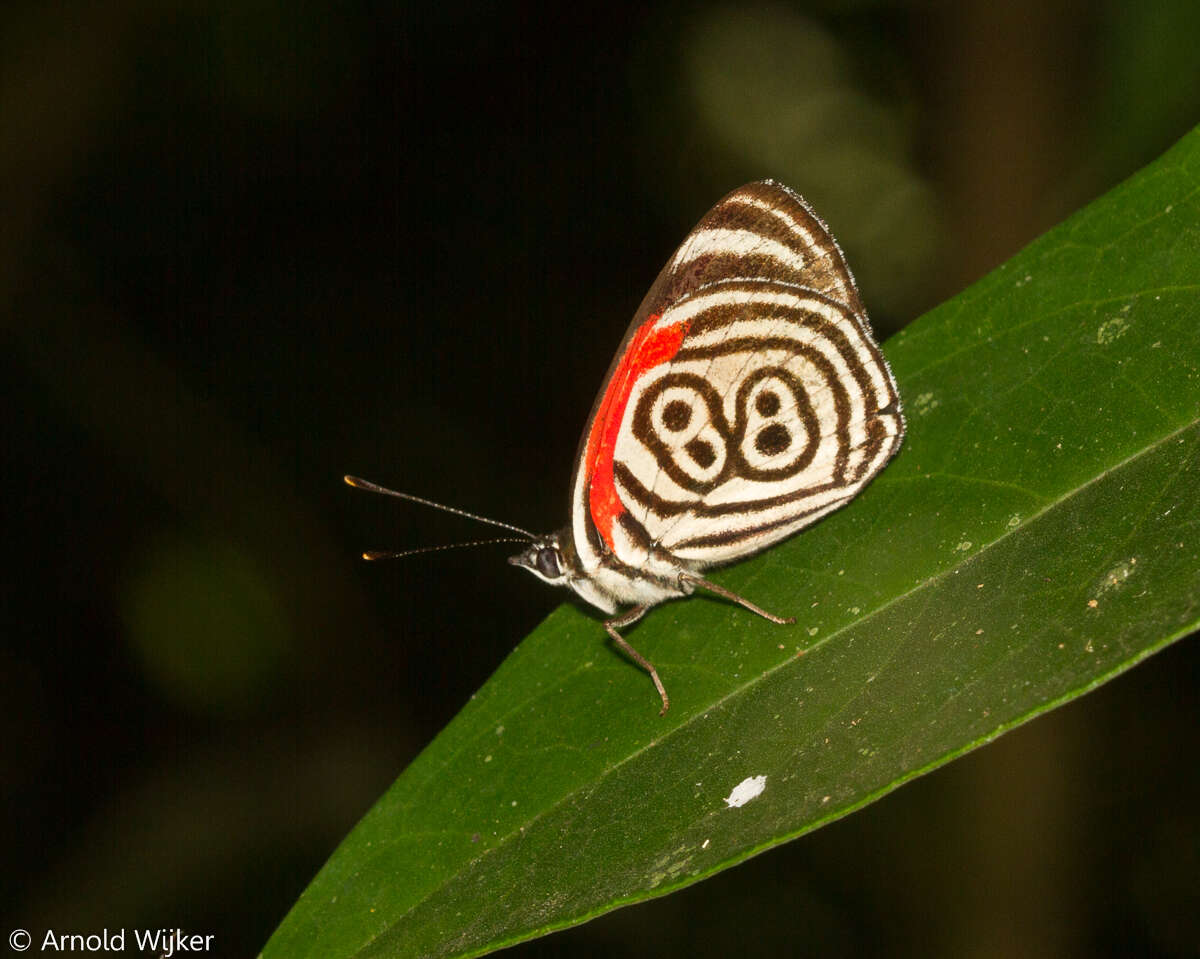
[584,314,688,549]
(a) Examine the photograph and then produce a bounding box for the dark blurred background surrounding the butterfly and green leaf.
[0,0,1200,957]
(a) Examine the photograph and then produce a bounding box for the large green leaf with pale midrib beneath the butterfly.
[263,133,1200,959]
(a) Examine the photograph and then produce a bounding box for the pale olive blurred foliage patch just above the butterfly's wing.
[683,7,943,318]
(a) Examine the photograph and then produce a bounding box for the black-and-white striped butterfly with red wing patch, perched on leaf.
[346,180,905,714]
